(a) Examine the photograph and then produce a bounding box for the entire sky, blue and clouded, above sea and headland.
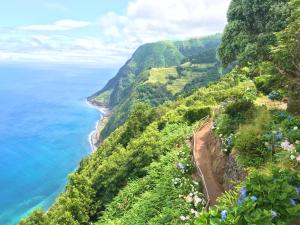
[0,0,230,68]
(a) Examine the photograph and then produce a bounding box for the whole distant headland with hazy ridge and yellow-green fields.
[90,35,222,139]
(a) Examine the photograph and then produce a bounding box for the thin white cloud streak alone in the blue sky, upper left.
[18,20,91,31]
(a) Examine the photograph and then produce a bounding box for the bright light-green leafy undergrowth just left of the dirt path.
[97,142,203,224]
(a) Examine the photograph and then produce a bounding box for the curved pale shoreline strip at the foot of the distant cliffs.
[87,99,111,153]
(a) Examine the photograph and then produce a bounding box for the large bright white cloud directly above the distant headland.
[100,0,230,46]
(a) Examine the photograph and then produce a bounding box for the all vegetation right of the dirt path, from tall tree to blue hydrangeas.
[197,0,300,222]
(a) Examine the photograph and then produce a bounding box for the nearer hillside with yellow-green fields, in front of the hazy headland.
[101,59,221,138]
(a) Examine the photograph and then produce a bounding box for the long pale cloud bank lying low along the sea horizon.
[0,35,128,67]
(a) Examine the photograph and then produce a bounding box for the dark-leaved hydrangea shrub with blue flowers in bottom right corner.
[196,168,300,225]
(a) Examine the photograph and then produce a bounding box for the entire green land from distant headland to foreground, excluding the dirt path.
[20,0,300,225]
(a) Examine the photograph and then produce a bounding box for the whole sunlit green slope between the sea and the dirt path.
[21,68,256,224]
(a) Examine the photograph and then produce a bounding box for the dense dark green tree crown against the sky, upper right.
[219,0,290,67]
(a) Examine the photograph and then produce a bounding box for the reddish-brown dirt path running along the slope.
[194,122,223,205]
